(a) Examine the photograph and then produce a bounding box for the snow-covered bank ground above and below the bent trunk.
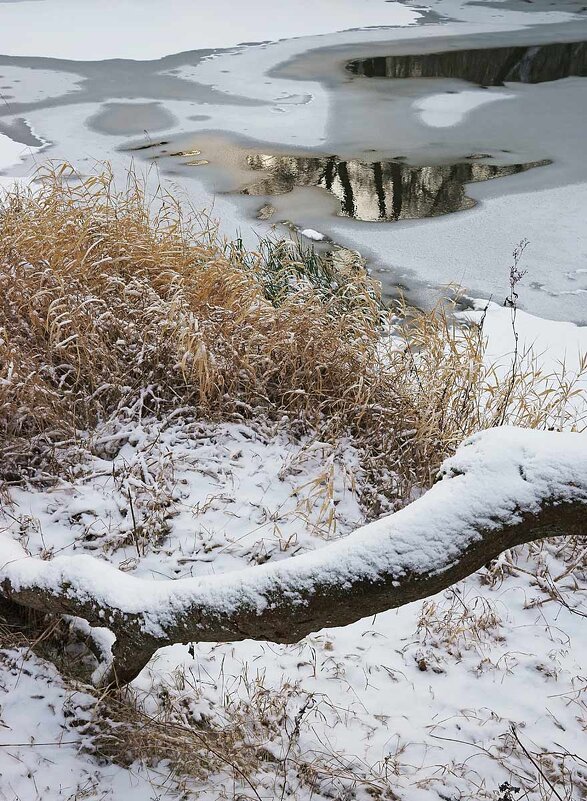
[0,296,587,801]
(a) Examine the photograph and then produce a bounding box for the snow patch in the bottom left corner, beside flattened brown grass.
[0,649,186,801]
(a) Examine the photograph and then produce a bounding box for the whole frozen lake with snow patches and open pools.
[0,0,587,324]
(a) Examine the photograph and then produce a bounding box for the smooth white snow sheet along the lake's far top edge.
[0,0,420,61]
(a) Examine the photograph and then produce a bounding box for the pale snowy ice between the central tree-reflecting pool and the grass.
[334,176,587,325]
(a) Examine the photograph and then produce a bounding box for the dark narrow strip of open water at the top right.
[347,42,587,86]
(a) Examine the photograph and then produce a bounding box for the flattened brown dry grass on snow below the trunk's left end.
[86,656,397,801]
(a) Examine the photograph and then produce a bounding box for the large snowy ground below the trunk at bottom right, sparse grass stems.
[137,580,584,801]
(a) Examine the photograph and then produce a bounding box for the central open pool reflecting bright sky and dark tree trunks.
[242,153,548,221]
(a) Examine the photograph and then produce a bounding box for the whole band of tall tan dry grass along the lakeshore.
[0,165,579,513]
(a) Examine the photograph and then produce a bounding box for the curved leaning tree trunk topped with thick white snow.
[0,426,587,683]
